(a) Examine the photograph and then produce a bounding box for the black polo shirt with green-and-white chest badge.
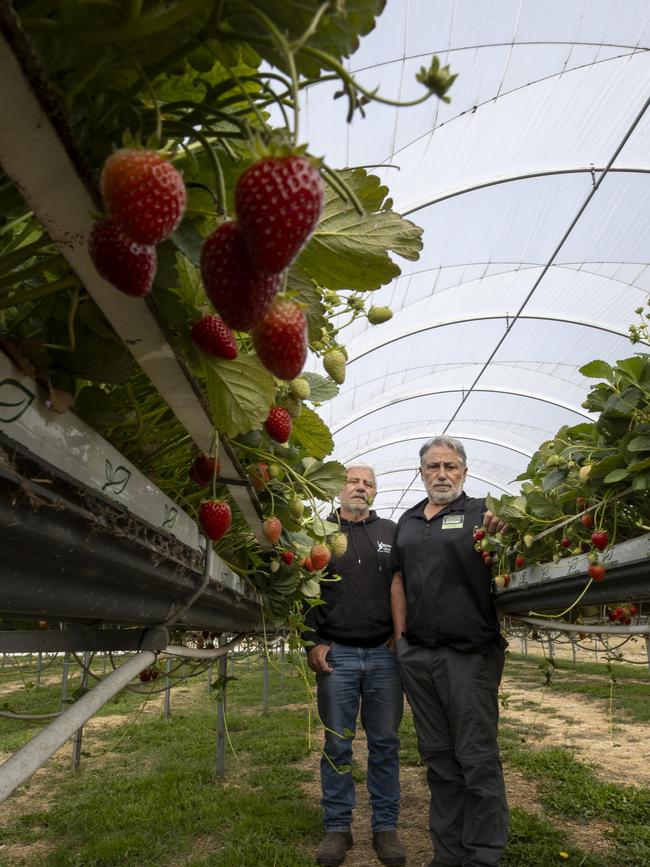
[391,493,505,652]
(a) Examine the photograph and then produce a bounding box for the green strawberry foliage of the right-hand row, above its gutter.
[488,353,650,566]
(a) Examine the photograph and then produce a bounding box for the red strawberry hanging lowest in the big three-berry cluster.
[252,298,307,381]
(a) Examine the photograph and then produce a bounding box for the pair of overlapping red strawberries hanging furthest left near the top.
[88,148,187,298]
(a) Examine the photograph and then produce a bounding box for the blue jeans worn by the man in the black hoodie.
[316,643,403,831]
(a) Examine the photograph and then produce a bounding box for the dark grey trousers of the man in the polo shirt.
[397,638,508,867]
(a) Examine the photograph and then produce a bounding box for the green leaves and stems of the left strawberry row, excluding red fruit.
[0,0,453,617]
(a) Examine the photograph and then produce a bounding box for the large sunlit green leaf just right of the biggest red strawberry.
[294,169,422,292]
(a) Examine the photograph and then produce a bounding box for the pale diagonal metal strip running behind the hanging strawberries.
[0,14,268,545]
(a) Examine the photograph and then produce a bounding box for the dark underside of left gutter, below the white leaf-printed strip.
[0,497,262,633]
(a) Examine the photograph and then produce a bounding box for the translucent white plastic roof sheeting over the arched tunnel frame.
[303,0,650,517]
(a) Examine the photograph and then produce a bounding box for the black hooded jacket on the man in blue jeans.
[303,511,396,647]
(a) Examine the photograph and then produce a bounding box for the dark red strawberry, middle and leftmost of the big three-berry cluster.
[201,221,282,331]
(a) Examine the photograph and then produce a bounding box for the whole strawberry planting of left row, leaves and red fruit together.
[0,0,453,618]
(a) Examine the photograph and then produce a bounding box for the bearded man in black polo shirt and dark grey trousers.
[391,436,508,867]
